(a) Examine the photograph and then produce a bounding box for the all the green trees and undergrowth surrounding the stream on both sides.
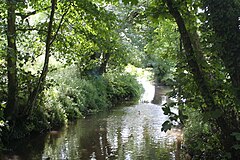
[0,0,240,159]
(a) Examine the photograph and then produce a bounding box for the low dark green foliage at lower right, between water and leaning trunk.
[184,109,226,160]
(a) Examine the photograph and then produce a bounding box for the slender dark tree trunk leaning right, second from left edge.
[24,0,57,115]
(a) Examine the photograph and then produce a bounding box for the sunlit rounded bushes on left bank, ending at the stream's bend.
[50,67,142,119]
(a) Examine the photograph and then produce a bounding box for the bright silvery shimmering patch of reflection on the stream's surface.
[108,105,170,160]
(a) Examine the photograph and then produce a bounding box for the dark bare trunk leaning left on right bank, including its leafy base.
[167,0,240,159]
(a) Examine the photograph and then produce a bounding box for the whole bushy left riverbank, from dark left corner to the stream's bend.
[1,68,142,145]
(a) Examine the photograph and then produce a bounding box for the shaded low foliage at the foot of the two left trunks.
[3,94,67,140]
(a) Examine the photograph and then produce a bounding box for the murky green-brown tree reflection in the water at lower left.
[42,116,111,160]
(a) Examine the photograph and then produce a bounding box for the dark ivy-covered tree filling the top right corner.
[203,0,240,103]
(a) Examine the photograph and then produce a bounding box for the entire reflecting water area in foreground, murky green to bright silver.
[40,104,173,160]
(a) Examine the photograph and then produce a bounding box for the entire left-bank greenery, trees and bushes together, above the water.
[0,0,142,143]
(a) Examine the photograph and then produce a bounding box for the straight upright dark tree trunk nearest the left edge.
[4,0,18,120]
